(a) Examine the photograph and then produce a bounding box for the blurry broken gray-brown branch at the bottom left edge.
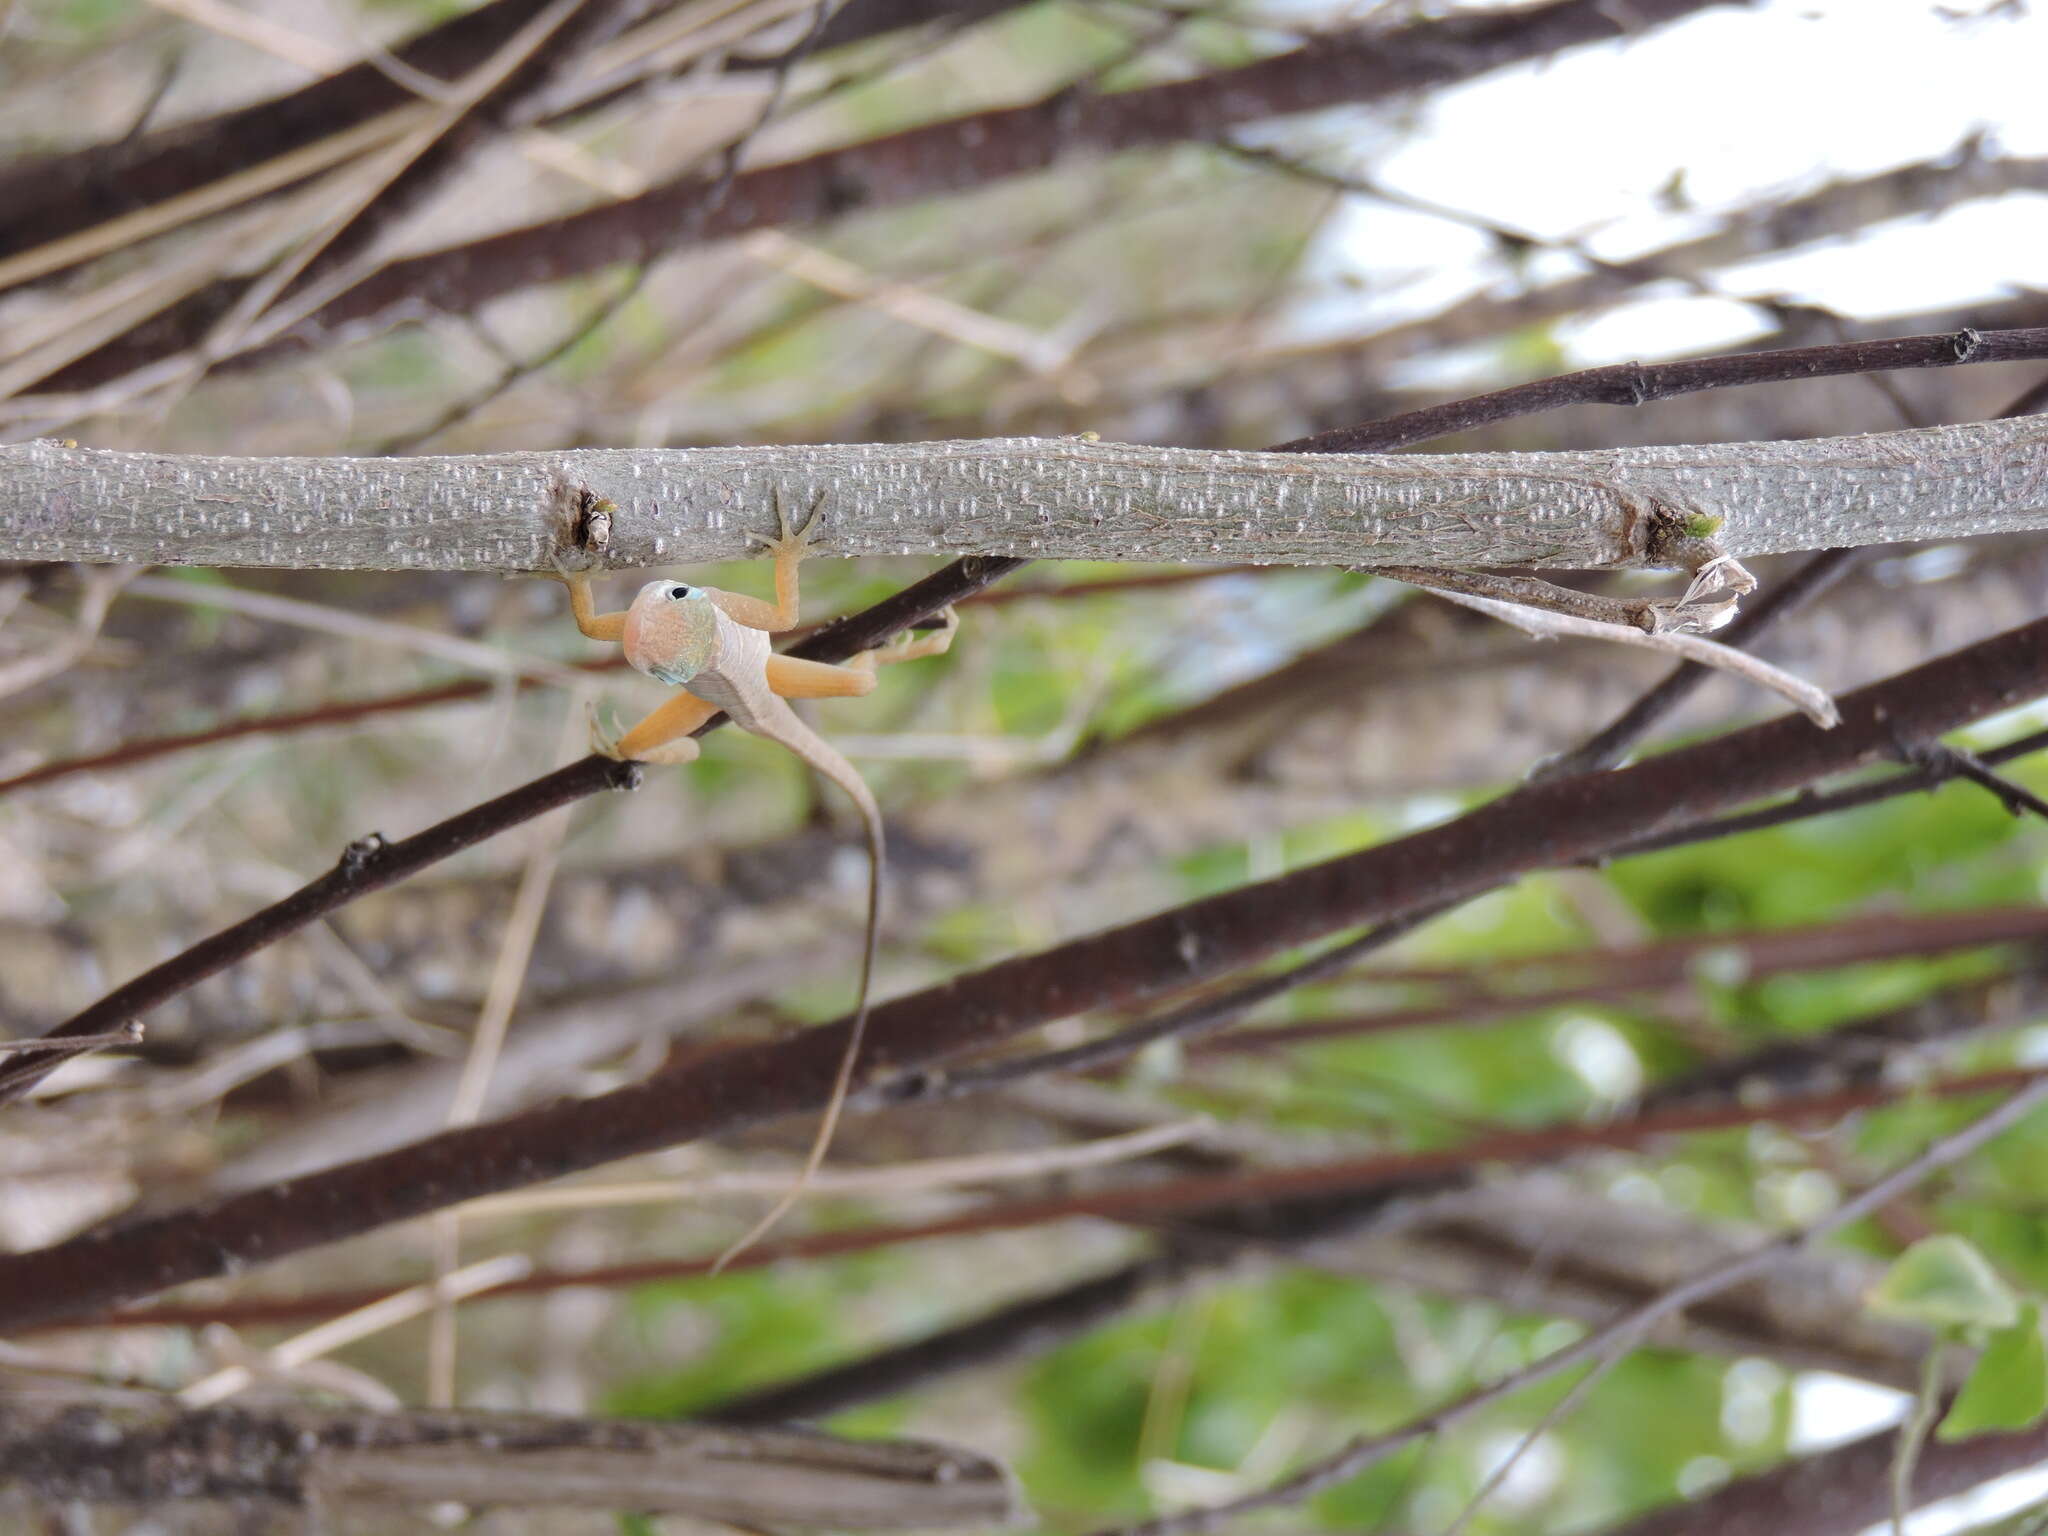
[0,1393,1024,1530]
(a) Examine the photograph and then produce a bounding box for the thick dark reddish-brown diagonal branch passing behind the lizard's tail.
[0,606,2048,1327]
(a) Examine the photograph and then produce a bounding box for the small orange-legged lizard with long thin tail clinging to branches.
[557,494,958,1270]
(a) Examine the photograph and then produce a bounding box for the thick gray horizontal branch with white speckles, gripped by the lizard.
[0,418,2048,571]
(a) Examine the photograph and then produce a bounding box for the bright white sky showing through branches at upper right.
[1262,0,2048,387]
